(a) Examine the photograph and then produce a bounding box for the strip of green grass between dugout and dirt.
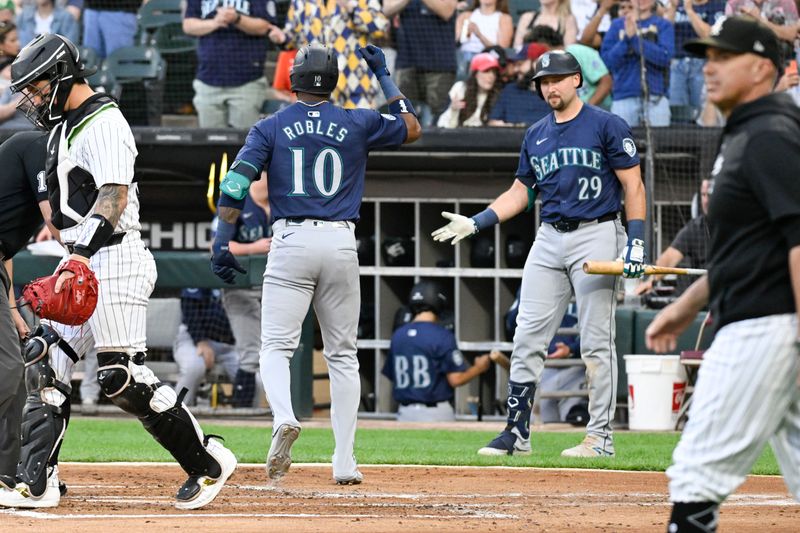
[61,417,780,474]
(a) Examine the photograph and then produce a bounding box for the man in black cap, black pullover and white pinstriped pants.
[646,17,800,533]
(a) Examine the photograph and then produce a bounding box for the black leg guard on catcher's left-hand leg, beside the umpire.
[17,324,78,498]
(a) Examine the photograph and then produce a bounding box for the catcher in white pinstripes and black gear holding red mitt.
[0,34,236,509]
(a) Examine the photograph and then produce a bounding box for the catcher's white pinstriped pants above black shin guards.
[45,231,157,405]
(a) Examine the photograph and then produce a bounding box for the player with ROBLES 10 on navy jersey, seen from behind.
[212,44,422,485]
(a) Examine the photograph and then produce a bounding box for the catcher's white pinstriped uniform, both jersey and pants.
[41,104,157,403]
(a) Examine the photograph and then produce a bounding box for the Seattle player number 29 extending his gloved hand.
[433,51,645,457]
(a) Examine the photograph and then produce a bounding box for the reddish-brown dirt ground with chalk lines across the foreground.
[0,464,800,533]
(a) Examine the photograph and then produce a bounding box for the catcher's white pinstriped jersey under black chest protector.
[48,94,141,242]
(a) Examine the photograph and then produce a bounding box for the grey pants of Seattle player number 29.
[510,219,626,451]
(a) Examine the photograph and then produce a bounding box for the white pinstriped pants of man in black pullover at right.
[667,314,800,502]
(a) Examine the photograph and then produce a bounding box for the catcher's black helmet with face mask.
[11,33,97,130]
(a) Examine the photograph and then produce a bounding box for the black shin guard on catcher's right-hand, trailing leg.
[97,352,222,478]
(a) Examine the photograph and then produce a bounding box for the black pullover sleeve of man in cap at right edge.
[743,130,800,248]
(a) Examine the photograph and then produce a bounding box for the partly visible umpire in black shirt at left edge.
[0,131,50,476]
